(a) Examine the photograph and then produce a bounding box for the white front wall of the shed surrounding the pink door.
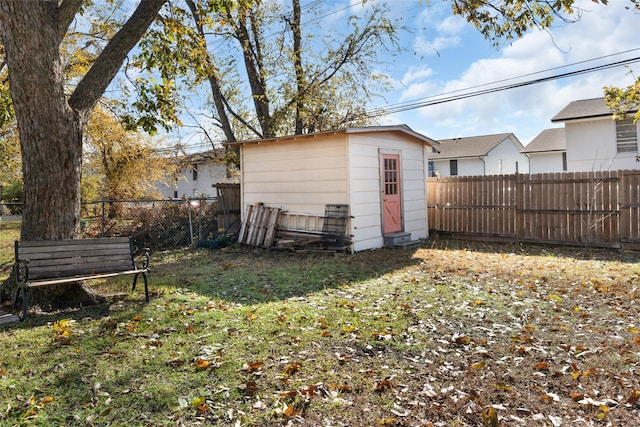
[349,132,427,251]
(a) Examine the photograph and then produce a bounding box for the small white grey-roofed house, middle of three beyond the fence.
[522,128,567,174]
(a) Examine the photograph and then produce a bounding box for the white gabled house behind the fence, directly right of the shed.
[429,133,529,176]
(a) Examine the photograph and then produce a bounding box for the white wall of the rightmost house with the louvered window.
[565,117,640,172]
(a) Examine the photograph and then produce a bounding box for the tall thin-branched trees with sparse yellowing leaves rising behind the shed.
[119,0,402,145]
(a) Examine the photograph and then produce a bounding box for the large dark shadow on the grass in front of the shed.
[150,246,421,305]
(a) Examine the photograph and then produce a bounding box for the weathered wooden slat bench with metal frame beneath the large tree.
[13,237,149,320]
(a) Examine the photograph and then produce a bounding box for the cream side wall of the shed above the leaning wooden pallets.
[241,135,349,214]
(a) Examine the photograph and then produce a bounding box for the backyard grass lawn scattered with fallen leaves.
[0,241,640,427]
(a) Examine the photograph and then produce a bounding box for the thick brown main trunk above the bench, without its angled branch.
[1,1,84,240]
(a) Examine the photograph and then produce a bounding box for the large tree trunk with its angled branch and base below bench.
[0,0,166,309]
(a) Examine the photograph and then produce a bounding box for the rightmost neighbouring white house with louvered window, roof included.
[551,98,640,172]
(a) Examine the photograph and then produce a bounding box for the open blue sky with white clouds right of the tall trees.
[323,0,640,145]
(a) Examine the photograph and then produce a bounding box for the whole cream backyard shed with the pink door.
[232,125,438,251]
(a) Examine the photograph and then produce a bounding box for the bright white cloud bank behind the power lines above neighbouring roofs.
[401,0,640,143]
